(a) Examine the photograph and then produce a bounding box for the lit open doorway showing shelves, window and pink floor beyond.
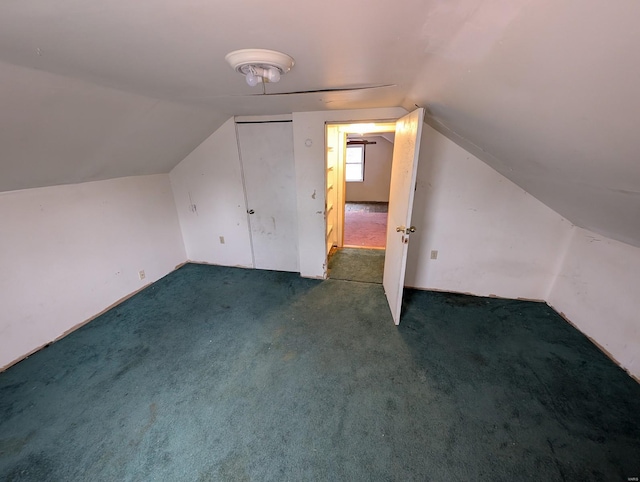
[326,122,396,283]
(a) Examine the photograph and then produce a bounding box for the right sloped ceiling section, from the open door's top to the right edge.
[405,0,640,246]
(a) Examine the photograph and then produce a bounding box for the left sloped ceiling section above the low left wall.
[0,63,227,191]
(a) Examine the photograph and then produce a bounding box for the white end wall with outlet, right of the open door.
[405,125,571,300]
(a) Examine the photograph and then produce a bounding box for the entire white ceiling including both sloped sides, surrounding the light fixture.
[0,0,640,246]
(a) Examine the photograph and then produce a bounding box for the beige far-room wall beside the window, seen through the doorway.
[346,136,393,202]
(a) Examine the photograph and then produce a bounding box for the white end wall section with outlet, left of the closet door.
[170,118,253,267]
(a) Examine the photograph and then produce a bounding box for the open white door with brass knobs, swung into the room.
[382,109,424,325]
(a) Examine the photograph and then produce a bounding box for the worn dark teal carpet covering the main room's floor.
[0,265,640,481]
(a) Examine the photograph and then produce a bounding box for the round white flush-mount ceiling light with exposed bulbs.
[225,49,294,87]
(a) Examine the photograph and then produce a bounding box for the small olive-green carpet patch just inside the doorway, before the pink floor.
[329,248,385,284]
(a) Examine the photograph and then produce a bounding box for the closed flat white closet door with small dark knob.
[237,122,299,271]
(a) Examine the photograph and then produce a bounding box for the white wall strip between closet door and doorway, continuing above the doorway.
[293,107,407,278]
